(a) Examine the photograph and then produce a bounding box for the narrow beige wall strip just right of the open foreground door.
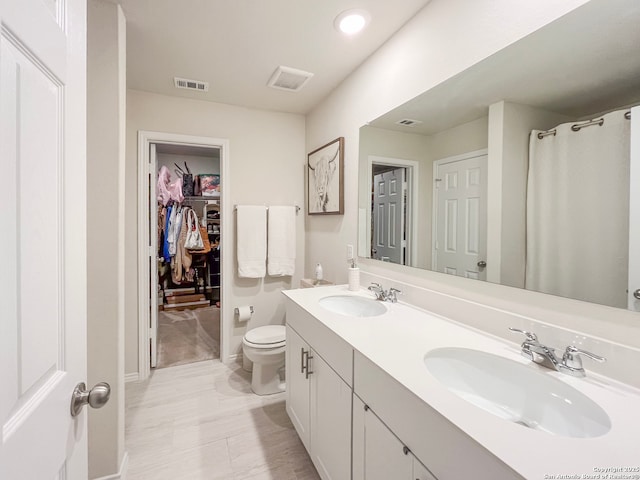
[87,0,126,478]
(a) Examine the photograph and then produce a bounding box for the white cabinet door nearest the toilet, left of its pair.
[285,325,310,451]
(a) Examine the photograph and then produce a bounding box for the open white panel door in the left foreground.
[0,0,87,480]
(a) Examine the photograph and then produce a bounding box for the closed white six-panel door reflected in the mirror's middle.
[433,154,487,280]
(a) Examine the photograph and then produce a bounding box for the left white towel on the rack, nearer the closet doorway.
[236,205,267,278]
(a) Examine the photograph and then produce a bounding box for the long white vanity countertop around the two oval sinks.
[283,285,640,479]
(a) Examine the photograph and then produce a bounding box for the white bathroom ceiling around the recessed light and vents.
[117,0,430,114]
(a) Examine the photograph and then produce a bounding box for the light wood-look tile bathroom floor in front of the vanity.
[125,360,320,480]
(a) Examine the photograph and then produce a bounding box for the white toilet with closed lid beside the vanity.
[242,325,285,395]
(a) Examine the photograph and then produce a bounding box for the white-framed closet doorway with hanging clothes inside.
[138,132,229,379]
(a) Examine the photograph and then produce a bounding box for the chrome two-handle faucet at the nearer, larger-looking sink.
[509,327,606,377]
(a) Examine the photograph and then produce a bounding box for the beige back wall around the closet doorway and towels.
[125,90,306,374]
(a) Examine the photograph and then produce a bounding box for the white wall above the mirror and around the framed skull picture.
[305,0,587,283]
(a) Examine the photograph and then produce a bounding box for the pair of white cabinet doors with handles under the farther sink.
[286,318,352,480]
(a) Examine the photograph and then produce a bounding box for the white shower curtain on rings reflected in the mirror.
[525,111,631,308]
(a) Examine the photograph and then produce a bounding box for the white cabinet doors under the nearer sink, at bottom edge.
[352,395,436,480]
